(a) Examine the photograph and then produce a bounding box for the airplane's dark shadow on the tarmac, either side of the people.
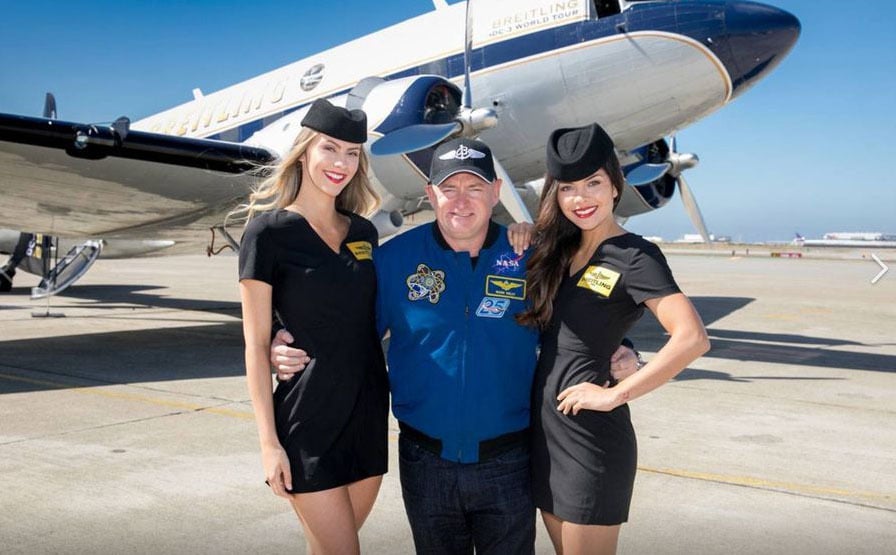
[0,296,896,394]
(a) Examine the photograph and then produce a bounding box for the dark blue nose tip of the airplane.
[714,2,800,96]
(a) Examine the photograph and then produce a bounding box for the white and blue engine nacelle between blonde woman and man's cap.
[362,75,462,203]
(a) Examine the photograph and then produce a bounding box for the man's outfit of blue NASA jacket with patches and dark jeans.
[374,219,538,553]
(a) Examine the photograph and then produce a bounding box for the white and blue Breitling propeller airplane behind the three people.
[0,0,800,297]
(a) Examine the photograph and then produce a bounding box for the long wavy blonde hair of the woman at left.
[225,127,380,223]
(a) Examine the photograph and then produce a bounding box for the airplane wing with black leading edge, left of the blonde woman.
[0,113,274,237]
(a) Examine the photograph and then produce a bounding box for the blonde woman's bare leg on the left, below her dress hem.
[291,486,361,555]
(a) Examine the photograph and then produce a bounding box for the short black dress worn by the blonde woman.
[239,209,389,493]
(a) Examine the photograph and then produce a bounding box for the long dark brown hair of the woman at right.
[516,152,625,330]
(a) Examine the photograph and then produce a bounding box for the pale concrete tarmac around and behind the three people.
[0,253,896,554]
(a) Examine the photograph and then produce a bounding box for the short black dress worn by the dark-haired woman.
[532,233,679,525]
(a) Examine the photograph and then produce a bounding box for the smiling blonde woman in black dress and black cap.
[239,100,389,554]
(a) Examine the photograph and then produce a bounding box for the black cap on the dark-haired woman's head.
[547,123,613,182]
